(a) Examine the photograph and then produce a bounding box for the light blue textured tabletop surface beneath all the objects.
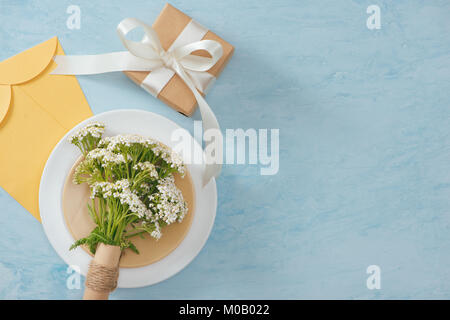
[0,0,450,299]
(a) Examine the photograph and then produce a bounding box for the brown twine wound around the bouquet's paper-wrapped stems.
[86,261,119,292]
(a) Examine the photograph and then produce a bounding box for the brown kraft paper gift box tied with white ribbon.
[124,4,234,116]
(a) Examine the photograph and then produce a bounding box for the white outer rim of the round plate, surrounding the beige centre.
[39,110,217,288]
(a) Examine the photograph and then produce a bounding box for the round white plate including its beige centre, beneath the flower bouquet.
[39,109,217,288]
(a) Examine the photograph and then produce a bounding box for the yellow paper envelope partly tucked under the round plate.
[0,37,92,221]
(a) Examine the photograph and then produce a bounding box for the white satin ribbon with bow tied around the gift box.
[52,18,223,184]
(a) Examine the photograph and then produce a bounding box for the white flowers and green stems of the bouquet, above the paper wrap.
[69,122,188,254]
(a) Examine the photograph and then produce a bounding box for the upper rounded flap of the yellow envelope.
[0,37,57,85]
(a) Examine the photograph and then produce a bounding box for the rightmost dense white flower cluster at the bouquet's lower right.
[148,175,188,224]
